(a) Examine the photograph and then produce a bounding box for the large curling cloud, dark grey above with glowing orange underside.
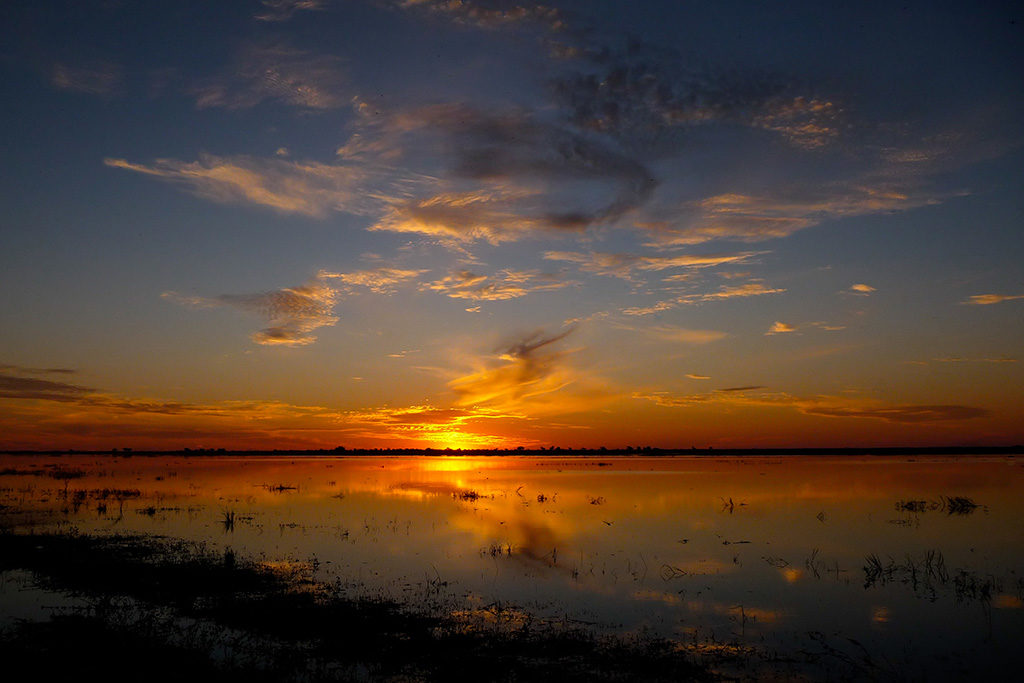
[348,104,656,244]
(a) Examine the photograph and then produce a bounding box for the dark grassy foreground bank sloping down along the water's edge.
[0,531,713,681]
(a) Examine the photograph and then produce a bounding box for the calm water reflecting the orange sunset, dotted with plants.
[0,457,1024,678]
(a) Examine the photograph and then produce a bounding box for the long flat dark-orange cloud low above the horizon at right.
[633,386,991,424]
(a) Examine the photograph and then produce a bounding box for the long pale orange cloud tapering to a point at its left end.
[103,155,380,217]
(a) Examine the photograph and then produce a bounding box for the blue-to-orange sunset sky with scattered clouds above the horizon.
[0,0,1024,450]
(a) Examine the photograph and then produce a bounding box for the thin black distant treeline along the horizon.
[0,444,1024,457]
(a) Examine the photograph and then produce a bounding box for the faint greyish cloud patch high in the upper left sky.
[193,44,349,111]
